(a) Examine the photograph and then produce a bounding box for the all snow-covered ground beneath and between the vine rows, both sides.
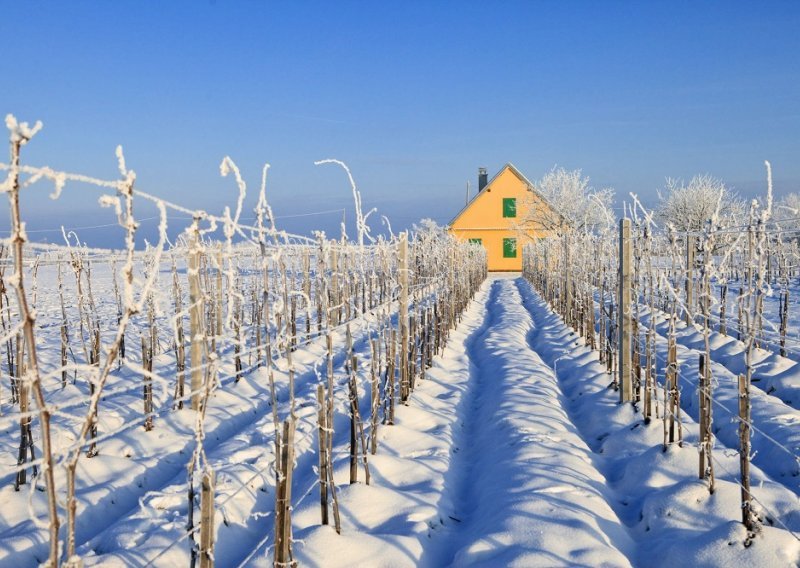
[0,276,800,567]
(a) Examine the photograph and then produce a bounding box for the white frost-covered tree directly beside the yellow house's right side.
[521,167,614,233]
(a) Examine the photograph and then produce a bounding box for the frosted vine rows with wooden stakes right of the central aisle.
[523,163,800,534]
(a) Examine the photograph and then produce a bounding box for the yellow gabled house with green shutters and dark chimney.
[448,163,562,272]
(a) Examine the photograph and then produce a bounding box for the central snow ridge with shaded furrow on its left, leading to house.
[422,278,632,566]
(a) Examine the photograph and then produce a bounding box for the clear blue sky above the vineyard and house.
[0,0,800,244]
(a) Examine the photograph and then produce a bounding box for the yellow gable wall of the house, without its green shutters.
[450,167,546,271]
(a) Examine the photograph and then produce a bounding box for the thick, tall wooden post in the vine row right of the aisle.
[617,219,633,403]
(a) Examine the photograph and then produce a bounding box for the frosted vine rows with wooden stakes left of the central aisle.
[0,115,486,566]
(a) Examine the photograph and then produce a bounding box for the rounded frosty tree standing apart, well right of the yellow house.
[656,175,745,231]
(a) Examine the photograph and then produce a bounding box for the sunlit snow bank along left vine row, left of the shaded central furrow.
[274,283,488,568]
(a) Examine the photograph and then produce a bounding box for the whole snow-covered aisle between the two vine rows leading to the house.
[288,277,800,566]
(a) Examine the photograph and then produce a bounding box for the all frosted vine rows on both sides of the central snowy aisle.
[6,113,800,566]
